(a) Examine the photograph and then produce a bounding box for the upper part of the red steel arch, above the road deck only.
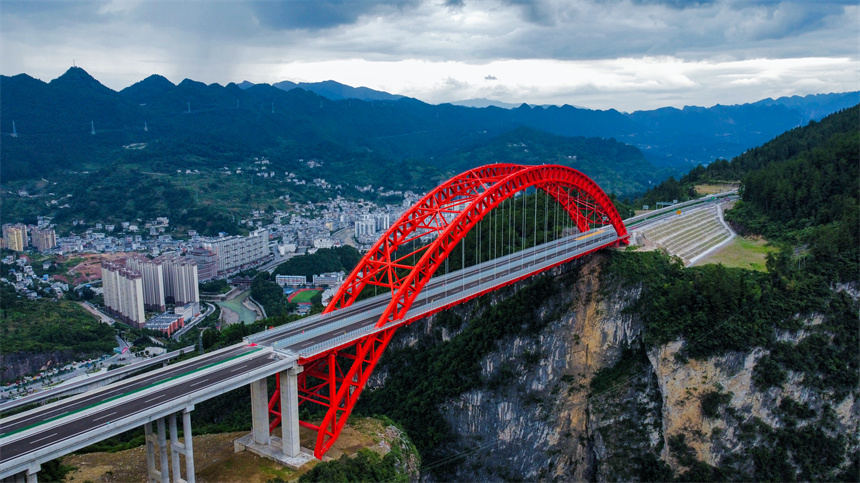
[325,164,627,327]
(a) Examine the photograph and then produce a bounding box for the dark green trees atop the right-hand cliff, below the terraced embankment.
[607,250,860,399]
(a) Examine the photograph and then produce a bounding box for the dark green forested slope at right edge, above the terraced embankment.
[727,106,860,282]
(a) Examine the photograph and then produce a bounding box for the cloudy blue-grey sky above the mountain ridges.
[0,0,860,112]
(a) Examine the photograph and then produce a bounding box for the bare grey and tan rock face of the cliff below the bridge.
[371,254,860,481]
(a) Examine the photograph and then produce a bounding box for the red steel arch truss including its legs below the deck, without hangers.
[269,164,627,458]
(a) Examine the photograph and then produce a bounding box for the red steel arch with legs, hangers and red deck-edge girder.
[269,164,628,458]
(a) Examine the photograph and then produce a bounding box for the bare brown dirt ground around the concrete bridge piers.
[63,417,397,483]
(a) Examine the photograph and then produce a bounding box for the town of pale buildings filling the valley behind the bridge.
[0,182,419,336]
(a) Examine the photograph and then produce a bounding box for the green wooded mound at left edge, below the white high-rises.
[0,283,116,356]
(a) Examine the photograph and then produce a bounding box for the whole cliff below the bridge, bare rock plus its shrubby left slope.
[363,253,860,481]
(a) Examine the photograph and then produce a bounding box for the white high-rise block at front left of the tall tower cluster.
[102,261,146,328]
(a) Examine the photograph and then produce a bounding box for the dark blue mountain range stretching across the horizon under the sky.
[0,67,860,189]
